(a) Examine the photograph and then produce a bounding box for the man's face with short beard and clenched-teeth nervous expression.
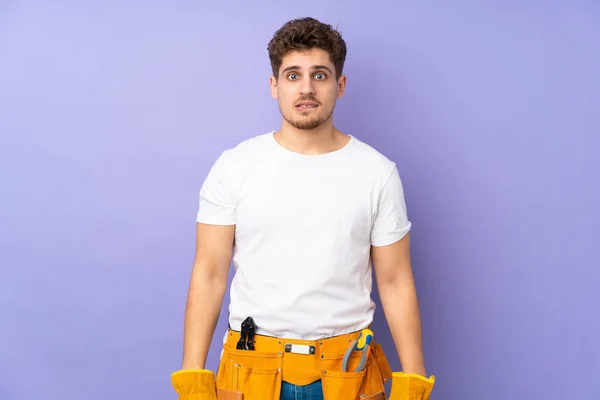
[270,49,346,130]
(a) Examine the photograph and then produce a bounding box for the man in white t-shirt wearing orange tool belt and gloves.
[172,18,434,400]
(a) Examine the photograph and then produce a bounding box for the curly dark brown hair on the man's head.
[267,17,347,79]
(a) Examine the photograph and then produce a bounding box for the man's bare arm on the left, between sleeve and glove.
[181,223,235,369]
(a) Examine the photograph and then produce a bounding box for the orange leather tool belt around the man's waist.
[215,329,392,400]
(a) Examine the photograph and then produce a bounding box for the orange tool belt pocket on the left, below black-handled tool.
[215,348,281,400]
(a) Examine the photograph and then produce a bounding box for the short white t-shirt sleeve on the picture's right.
[371,165,411,246]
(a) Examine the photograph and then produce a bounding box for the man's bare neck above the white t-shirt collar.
[274,120,350,155]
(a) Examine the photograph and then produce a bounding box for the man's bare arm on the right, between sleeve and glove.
[371,234,426,376]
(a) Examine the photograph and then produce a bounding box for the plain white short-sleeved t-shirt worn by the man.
[197,132,411,340]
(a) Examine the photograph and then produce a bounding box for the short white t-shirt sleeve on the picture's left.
[196,151,236,225]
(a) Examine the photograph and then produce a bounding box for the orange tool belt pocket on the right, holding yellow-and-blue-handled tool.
[321,351,385,400]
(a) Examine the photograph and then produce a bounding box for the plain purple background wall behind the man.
[0,0,600,400]
